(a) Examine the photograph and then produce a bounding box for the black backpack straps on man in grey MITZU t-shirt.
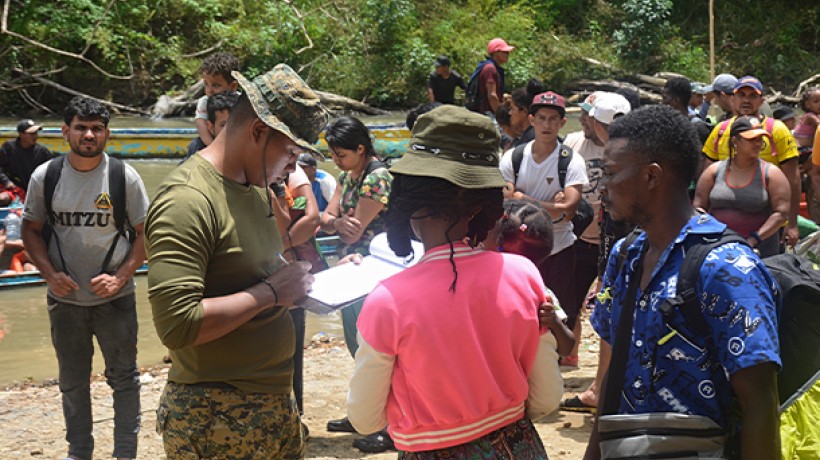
[42,155,136,273]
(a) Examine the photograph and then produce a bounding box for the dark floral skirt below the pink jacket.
[399,417,549,460]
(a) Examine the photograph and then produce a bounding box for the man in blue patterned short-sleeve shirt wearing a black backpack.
[585,106,780,459]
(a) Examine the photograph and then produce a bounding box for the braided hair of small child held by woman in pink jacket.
[498,199,553,265]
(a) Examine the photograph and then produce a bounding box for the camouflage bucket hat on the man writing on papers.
[231,64,327,161]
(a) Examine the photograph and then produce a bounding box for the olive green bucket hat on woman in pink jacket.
[390,105,506,189]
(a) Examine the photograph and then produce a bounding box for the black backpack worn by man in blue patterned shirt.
[616,229,820,403]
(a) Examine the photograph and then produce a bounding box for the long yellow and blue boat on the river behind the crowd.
[0,123,410,159]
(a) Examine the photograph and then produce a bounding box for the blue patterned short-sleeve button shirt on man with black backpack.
[591,214,780,427]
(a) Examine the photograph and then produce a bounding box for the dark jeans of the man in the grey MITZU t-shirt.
[48,294,140,460]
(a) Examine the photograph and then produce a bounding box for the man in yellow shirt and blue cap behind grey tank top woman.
[703,75,802,246]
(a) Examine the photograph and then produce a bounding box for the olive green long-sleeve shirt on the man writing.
[145,155,294,394]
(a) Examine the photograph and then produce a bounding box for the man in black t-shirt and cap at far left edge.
[0,120,52,206]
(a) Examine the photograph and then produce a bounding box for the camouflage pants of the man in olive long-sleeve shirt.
[157,382,305,460]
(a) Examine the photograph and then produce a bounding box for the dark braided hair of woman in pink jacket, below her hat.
[386,174,504,291]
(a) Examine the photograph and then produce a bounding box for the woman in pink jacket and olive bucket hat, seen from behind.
[348,105,563,460]
